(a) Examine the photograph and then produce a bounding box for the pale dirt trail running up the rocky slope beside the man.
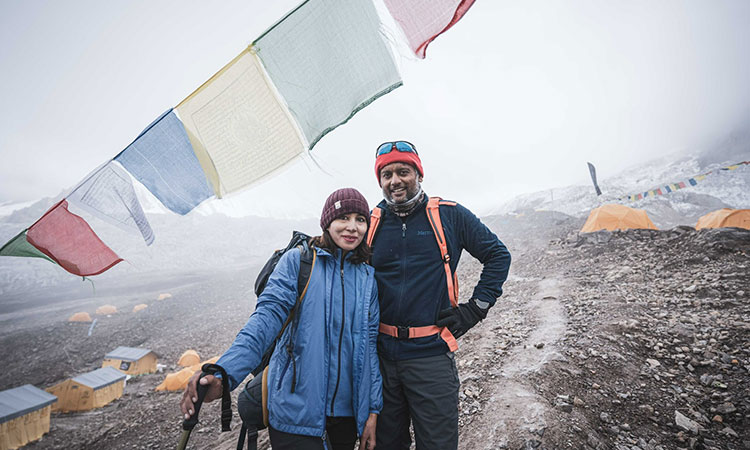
[459,278,566,450]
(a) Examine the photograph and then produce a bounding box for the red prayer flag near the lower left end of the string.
[26,199,122,277]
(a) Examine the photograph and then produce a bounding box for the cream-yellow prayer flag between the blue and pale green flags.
[175,48,305,197]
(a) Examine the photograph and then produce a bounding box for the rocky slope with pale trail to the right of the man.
[459,223,750,450]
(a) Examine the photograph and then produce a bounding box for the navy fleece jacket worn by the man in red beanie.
[372,196,510,361]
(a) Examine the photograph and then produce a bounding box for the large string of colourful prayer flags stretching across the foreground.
[0,0,474,276]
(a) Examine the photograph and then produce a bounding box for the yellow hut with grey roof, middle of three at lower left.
[47,367,125,412]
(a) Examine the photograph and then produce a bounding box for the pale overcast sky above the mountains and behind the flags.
[0,0,750,217]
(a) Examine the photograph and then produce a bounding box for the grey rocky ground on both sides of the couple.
[0,213,750,450]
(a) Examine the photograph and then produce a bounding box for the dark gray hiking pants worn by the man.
[375,352,459,450]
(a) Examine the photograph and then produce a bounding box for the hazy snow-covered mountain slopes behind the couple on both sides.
[0,128,750,299]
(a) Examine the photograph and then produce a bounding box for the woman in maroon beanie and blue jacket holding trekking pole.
[181,188,382,450]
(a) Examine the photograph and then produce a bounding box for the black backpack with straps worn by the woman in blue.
[237,231,316,450]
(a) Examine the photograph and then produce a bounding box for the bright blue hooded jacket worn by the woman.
[217,248,383,436]
